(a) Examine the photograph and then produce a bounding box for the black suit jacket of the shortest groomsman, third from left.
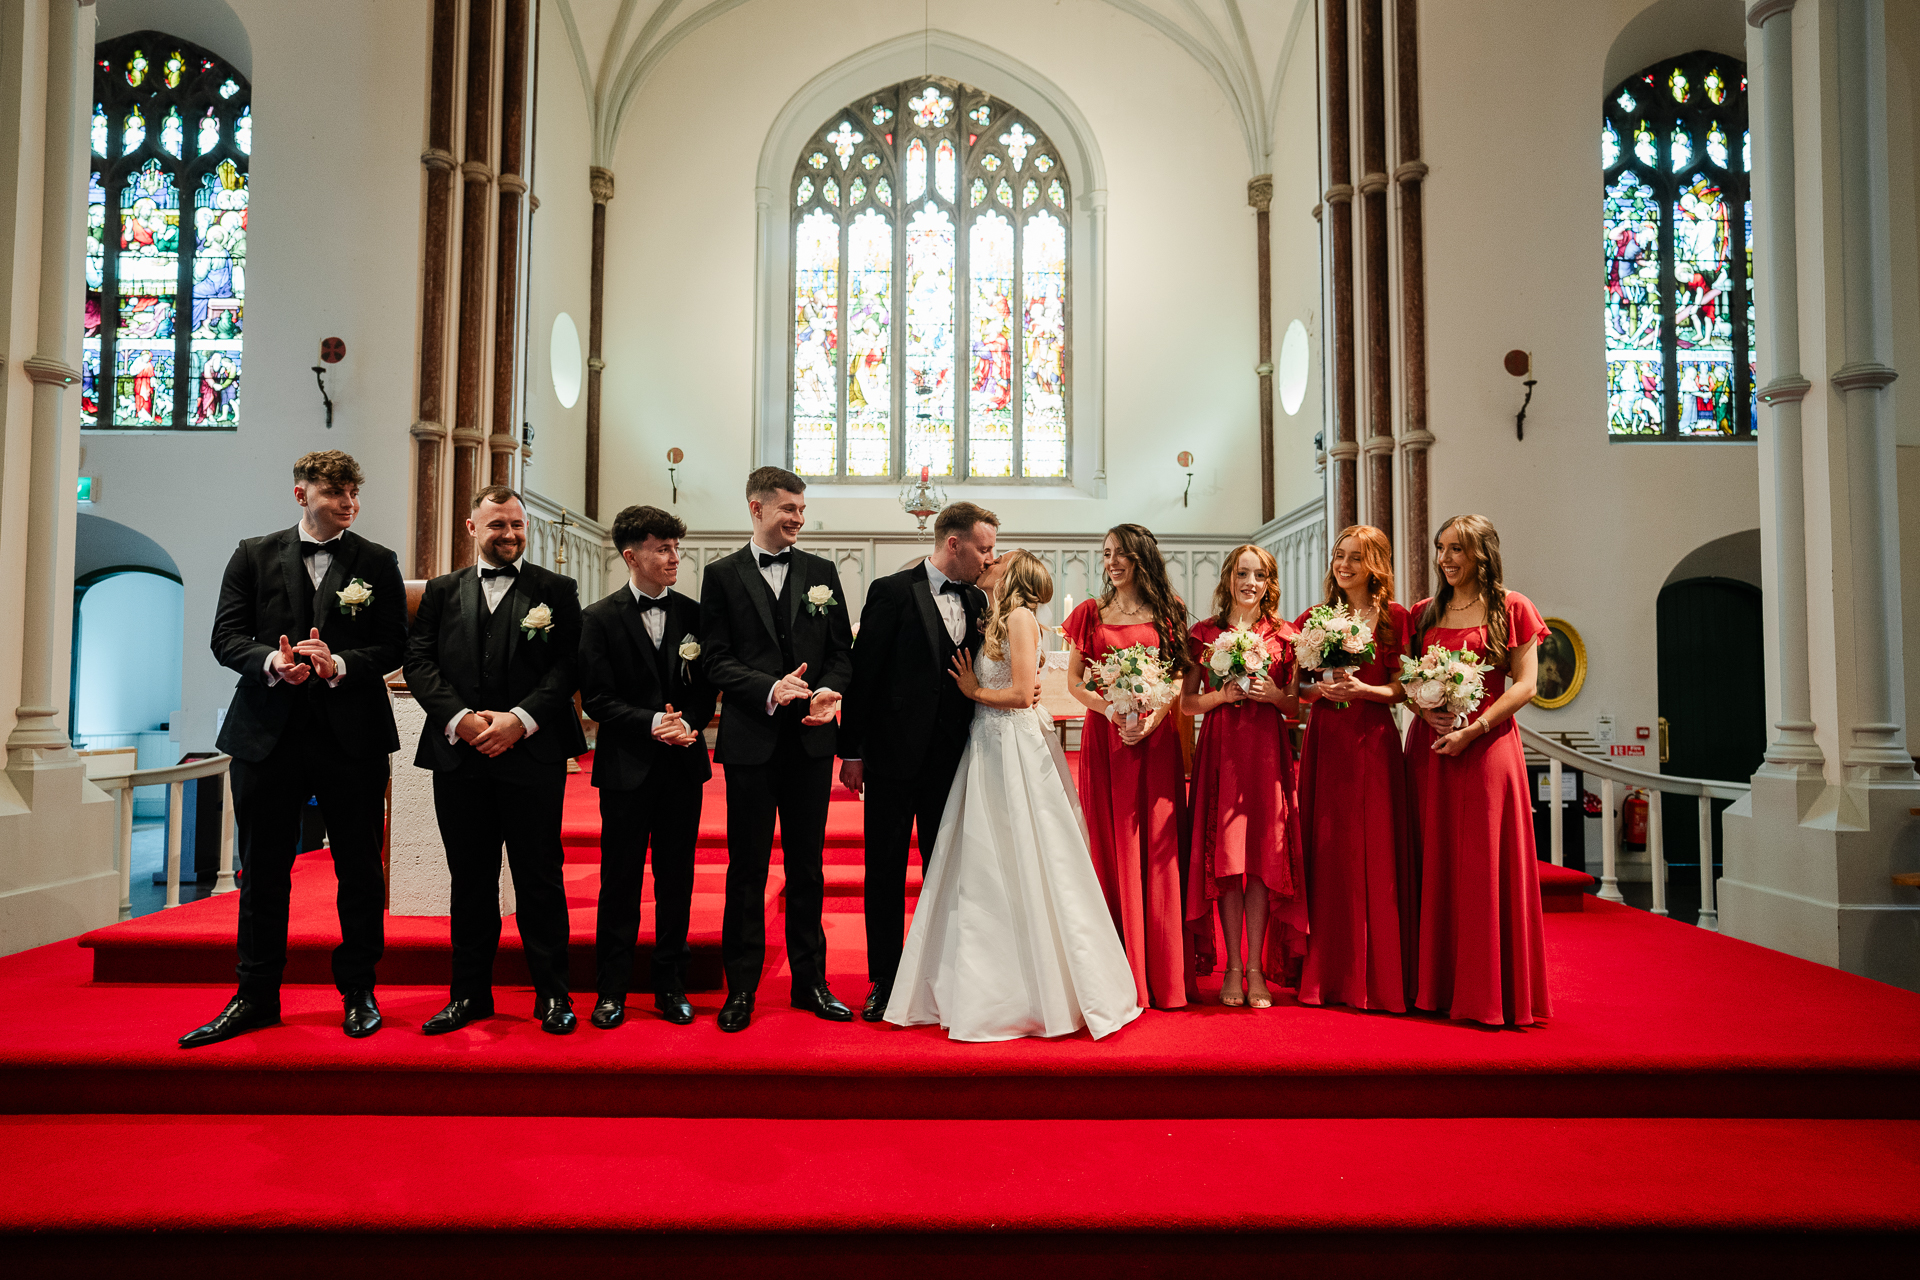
[580,583,714,791]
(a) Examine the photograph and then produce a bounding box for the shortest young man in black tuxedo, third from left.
[580,507,714,1031]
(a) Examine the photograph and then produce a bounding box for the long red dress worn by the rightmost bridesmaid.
[1407,591,1551,1027]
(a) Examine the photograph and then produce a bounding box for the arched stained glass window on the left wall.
[81,31,253,430]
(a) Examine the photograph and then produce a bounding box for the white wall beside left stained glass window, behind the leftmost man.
[83,0,428,750]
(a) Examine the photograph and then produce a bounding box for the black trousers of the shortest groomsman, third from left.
[593,775,701,1000]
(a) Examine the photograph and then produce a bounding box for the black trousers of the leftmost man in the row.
[232,725,388,1007]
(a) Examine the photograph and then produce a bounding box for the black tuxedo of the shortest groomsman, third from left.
[580,583,714,1000]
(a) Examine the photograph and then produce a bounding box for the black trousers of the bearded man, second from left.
[434,748,568,1002]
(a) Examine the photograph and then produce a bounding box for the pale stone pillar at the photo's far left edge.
[6,0,89,767]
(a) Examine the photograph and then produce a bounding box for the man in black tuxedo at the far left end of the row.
[180,449,407,1048]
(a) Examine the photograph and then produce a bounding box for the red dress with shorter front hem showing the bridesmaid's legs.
[1187,618,1308,981]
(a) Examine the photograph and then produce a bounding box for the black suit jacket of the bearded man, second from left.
[407,558,588,770]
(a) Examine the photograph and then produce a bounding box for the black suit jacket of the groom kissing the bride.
[839,562,987,777]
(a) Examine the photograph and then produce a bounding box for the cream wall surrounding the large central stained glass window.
[601,0,1290,535]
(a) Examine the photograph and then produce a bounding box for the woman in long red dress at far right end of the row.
[1407,516,1549,1027]
